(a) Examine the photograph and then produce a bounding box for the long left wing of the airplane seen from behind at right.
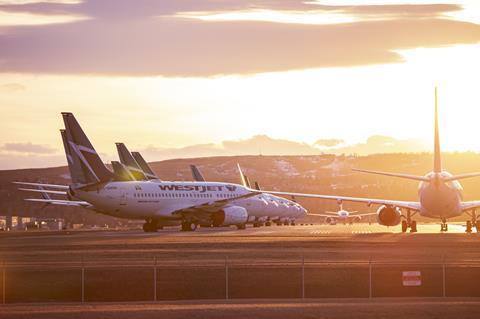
[261,190,420,211]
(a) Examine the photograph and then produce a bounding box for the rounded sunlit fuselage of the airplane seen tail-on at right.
[418,172,463,219]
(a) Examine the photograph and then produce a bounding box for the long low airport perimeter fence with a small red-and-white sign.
[0,257,480,304]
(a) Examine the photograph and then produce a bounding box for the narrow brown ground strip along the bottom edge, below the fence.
[0,298,480,319]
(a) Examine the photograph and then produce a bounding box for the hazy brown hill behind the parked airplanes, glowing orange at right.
[0,153,480,225]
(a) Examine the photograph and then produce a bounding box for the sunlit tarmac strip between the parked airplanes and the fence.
[0,224,480,263]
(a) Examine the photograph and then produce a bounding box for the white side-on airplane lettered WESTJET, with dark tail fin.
[17,113,306,231]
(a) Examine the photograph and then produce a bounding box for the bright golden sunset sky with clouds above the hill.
[0,0,480,169]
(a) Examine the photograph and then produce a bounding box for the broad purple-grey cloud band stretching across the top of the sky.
[0,0,474,77]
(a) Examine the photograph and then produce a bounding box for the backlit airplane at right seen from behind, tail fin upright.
[265,88,480,232]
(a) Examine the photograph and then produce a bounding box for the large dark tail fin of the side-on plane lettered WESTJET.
[62,112,113,184]
